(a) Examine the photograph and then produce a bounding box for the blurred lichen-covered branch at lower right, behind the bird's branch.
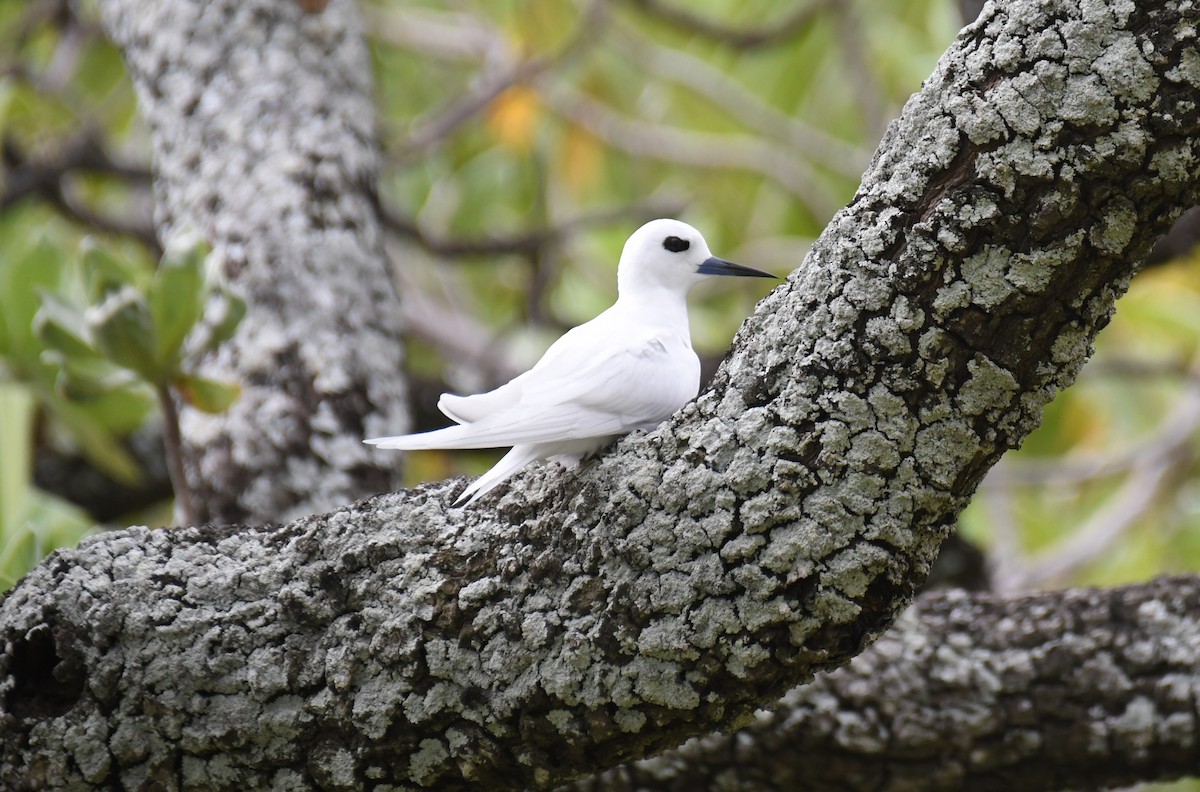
[572,576,1200,792]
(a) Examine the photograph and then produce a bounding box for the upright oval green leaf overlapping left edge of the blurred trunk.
[149,241,209,376]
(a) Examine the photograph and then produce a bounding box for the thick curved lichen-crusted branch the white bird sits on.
[0,0,1200,788]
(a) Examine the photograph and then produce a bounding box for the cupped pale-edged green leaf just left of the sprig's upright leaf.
[84,284,162,385]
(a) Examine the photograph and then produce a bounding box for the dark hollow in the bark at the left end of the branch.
[8,624,83,720]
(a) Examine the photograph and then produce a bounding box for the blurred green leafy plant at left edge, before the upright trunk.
[0,219,246,590]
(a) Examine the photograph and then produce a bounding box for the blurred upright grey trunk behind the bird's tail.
[100,0,406,523]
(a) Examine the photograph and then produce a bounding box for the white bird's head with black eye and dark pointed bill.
[617,218,775,295]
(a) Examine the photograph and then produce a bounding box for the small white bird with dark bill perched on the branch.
[366,220,775,505]
